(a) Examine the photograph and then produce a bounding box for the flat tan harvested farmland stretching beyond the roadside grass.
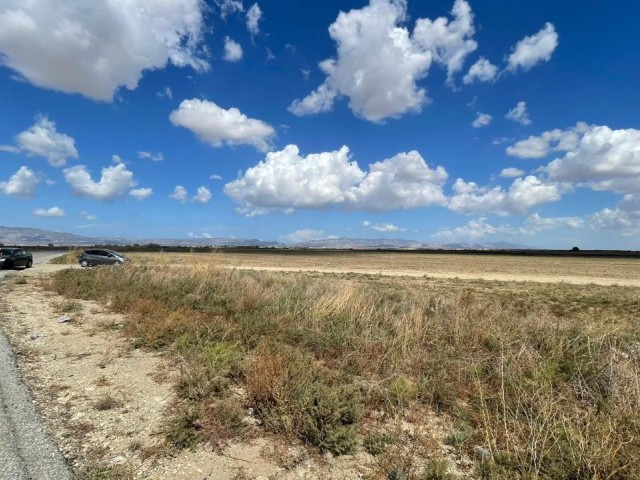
[132,250,640,287]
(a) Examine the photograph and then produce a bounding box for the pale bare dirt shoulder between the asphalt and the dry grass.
[0,265,378,480]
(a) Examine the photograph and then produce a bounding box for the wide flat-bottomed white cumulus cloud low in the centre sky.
[224,145,447,215]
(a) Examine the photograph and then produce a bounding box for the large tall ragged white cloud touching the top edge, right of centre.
[289,0,477,123]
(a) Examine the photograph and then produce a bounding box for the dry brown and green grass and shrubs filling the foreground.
[49,259,640,480]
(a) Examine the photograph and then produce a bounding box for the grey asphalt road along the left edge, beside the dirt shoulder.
[0,252,73,480]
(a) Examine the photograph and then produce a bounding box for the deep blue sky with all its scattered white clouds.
[0,0,640,250]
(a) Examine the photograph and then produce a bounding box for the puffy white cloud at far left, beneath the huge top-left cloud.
[7,116,78,167]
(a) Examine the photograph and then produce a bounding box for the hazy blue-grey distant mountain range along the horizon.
[0,226,530,250]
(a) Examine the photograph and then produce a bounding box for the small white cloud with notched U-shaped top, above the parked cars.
[64,163,135,201]
